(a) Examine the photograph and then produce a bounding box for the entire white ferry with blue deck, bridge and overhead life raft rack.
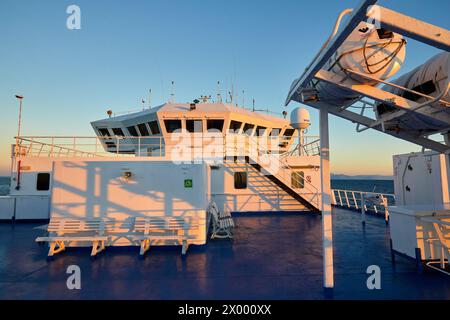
[0,0,450,300]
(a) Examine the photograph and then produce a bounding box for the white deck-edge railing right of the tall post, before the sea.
[331,189,395,221]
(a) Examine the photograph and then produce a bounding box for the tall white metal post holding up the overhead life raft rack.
[319,108,334,289]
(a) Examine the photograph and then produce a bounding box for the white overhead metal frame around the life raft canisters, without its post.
[285,0,450,153]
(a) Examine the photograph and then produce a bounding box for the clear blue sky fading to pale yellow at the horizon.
[0,0,450,175]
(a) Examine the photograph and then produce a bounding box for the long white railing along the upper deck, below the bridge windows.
[13,134,319,157]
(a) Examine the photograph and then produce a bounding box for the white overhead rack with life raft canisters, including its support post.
[286,0,450,288]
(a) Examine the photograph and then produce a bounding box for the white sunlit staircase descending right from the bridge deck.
[224,135,320,212]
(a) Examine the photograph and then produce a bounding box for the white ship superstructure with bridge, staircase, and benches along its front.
[0,102,321,257]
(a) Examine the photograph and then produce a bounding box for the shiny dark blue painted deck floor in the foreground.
[0,208,450,299]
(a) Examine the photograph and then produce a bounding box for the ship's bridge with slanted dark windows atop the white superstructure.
[91,103,298,156]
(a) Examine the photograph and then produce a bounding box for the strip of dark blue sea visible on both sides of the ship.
[0,177,394,196]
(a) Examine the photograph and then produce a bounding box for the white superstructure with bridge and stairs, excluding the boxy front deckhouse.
[0,103,321,225]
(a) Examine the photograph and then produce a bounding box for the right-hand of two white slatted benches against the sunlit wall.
[132,217,199,257]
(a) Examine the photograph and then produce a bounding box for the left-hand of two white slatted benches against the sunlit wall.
[36,218,108,257]
